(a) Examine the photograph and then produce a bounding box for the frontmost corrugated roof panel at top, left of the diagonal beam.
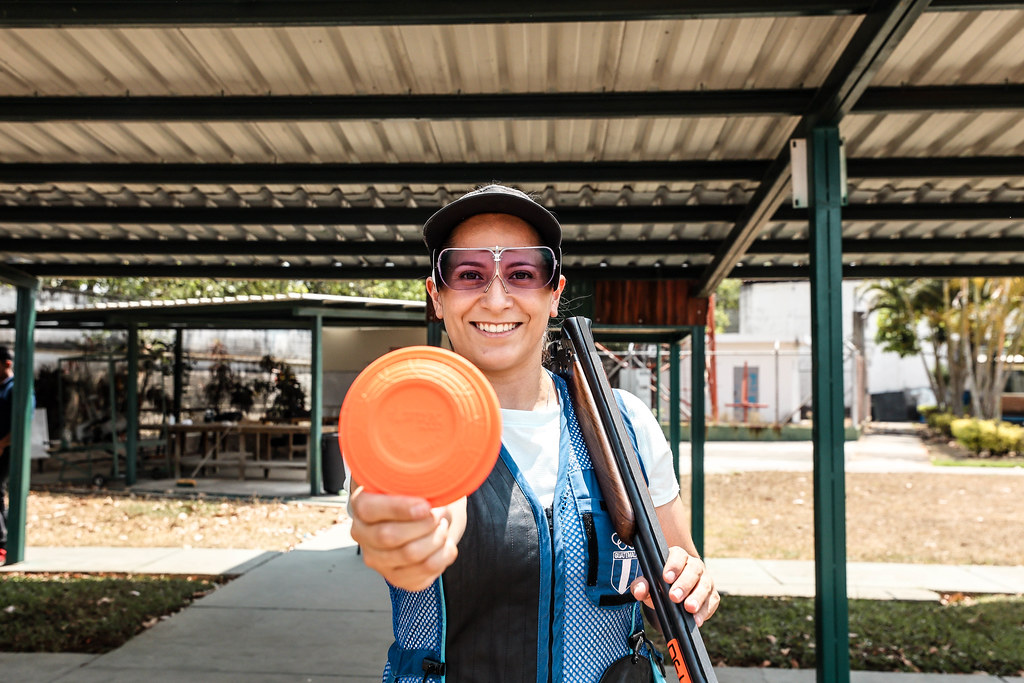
[0,16,860,95]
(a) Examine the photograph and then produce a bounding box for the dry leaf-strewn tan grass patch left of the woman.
[26,492,344,551]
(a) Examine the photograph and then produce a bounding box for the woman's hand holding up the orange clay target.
[348,486,466,591]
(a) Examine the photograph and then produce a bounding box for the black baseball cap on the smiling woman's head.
[423,184,562,285]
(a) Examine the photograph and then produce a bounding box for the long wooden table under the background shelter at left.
[168,422,319,479]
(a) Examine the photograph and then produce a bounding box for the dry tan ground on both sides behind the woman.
[16,446,1024,564]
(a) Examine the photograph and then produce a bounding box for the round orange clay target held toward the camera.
[338,346,502,507]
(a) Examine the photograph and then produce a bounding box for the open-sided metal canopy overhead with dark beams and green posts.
[0,0,1024,682]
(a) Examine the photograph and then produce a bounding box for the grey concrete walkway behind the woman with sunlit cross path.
[0,524,1024,683]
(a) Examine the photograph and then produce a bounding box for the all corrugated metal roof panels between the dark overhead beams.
[0,9,1024,276]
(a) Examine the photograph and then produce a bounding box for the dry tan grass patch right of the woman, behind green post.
[696,472,1024,564]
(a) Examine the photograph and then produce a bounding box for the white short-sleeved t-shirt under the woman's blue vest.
[502,391,679,507]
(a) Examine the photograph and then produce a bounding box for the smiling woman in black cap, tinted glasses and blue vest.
[349,185,719,683]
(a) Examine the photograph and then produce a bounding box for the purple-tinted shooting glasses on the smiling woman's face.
[436,247,558,293]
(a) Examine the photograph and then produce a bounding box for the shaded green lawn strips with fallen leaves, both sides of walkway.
[0,574,1024,676]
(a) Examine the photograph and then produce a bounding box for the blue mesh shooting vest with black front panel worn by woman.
[384,376,642,683]
